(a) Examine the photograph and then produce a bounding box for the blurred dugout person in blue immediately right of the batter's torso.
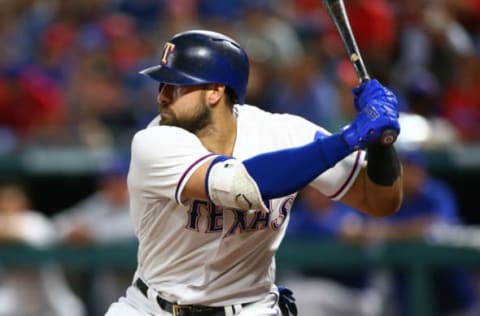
[279,187,387,316]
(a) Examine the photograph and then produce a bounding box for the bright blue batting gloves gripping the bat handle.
[342,80,400,150]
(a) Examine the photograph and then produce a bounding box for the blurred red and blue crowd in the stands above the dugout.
[0,0,480,153]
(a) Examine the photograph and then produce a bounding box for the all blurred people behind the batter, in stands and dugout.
[0,0,480,316]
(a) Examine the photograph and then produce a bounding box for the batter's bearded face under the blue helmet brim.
[158,85,212,133]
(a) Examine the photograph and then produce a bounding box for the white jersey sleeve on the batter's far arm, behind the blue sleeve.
[272,114,365,200]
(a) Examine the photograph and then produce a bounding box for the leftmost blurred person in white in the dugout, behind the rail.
[0,183,85,316]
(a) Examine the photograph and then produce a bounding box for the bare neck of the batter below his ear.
[197,109,237,156]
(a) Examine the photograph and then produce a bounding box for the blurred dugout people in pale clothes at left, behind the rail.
[0,157,131,316]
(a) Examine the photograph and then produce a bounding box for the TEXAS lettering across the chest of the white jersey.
[185,196,295,236]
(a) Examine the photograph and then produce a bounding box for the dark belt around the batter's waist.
[135,278,225,316]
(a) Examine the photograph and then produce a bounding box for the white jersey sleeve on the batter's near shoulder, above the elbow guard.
[128,126,214,204]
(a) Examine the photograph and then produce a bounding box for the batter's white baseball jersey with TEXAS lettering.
[128,105,363,306]
